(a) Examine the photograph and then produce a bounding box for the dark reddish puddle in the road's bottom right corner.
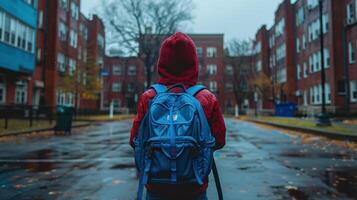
[325,168,357,198]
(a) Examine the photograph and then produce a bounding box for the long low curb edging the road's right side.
[245,119,357,142]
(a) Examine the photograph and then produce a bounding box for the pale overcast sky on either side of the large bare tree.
[81,0,283,41]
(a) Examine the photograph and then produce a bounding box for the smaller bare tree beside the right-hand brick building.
[226,39,253,107]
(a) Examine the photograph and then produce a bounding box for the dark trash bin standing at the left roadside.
[55,106,74,134]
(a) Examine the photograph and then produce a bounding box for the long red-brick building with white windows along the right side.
[248,0,357,113]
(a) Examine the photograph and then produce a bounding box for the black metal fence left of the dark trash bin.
[0,105,54,129]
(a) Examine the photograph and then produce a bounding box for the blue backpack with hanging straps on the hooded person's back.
[134,84,221,200]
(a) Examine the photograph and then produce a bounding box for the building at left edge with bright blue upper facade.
[0,0,37,105]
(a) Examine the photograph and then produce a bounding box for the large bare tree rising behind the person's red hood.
[102,0,193,86]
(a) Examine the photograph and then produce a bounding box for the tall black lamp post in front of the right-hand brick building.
[317,0,331,126]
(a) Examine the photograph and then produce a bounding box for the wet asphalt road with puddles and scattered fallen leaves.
[0,119,357,200]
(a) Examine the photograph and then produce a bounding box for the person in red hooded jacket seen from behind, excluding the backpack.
[130,32,226,200]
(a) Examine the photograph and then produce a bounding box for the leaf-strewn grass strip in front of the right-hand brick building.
[240,116,357,141]
